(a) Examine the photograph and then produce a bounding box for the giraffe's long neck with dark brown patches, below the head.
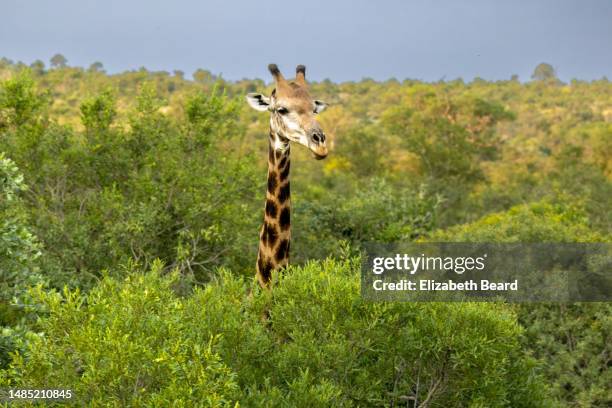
[257,130,291,287]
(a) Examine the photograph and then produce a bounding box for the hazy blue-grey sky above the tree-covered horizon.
[0,0,612,81]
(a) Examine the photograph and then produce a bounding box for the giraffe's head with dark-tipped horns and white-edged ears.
[247,64,327,159]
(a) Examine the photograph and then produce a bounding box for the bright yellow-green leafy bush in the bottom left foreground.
[2,264,237,407]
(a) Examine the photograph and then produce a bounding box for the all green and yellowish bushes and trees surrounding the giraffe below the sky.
[0,58,612,407]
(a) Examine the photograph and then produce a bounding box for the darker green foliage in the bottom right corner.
[519,303,612,408]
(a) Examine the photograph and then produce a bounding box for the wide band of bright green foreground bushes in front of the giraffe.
[2,259,546,407]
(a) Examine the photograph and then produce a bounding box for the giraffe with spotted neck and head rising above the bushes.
[246,64,327,288]
